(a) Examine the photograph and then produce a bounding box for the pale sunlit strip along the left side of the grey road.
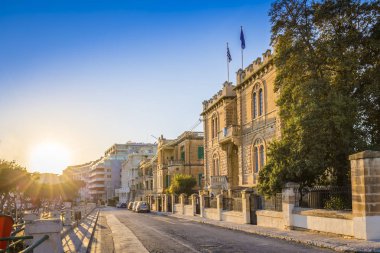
[106,214,149,253]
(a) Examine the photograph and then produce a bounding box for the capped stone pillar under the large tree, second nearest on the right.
[282,182,299,229]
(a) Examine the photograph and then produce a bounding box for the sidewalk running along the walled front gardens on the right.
[152,211,380,253]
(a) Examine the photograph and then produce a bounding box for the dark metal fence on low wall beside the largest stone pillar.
[295,186,352,210]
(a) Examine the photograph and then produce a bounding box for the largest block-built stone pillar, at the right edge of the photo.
[349,151,380,240]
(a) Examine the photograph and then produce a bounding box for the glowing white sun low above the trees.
[29,142,70,174]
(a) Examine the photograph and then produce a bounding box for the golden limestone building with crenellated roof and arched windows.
[201,50,280,192]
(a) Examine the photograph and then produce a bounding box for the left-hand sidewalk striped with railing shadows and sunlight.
[62,209,99,253]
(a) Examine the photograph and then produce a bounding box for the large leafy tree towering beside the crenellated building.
[259,0,380,194]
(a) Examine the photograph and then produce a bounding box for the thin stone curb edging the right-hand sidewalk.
[151,212,380,253]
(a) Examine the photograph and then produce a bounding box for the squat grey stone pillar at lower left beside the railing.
[26,219,63,253]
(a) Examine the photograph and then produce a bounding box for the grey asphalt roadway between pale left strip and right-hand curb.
[98,209,332,253]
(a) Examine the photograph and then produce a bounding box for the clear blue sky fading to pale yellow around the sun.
[0,0,270,173]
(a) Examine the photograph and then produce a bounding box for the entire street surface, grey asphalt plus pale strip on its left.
[91,208,332,253]
